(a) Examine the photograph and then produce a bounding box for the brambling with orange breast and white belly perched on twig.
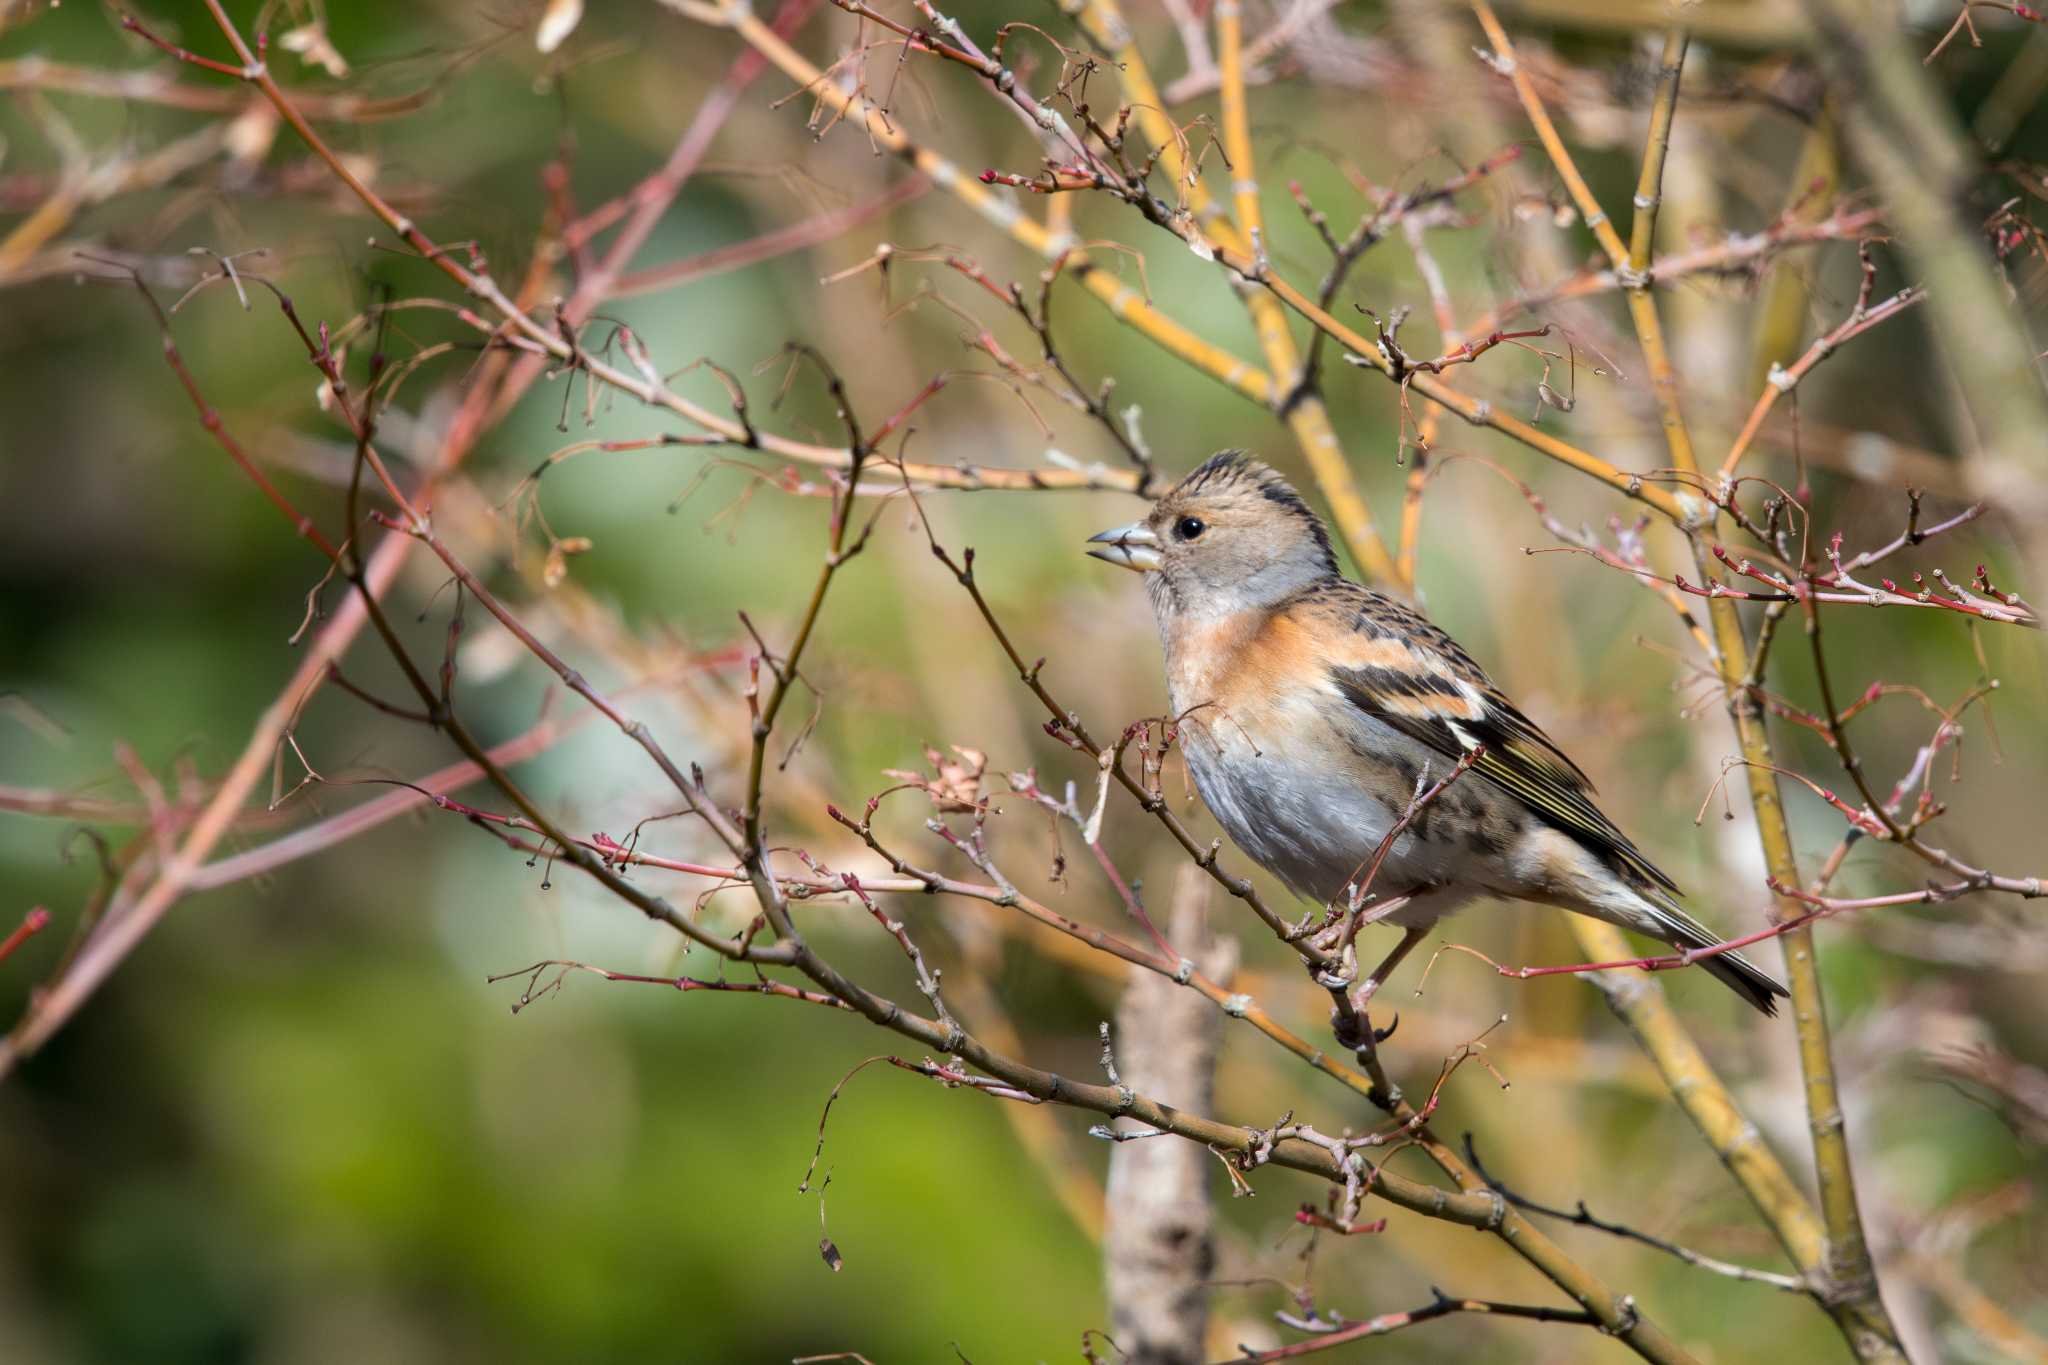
[1087,450,1786,1015]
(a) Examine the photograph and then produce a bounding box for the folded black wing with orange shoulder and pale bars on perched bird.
[1298,583,1677,892]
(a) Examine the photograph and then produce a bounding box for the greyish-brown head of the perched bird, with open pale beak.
[1087,450,1337,624]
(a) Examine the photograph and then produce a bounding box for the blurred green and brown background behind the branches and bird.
[0,2,2048,1363]
